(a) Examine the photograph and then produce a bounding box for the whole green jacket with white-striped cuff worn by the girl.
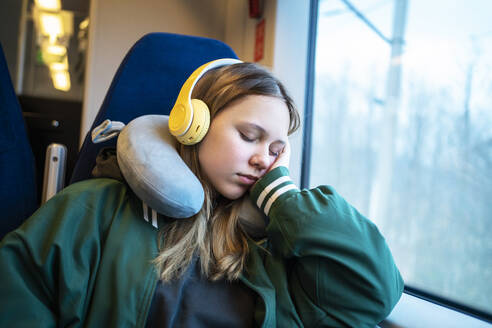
[0,167,403,327]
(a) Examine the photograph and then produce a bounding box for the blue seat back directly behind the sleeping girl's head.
[70,33,237,183]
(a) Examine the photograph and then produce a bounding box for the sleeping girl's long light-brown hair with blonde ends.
[154,63,300,281]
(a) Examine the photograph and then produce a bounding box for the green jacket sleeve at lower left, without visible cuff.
[0,179,122,327]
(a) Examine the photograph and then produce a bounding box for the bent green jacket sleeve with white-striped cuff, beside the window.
[251,167,403,327]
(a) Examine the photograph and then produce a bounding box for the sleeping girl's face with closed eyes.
[198,95,290,199]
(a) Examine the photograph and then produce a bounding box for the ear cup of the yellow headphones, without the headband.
[178,99,210,145]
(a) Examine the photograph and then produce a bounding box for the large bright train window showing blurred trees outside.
[309,0,492,320]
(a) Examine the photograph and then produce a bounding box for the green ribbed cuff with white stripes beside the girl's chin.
[250,166,299,215]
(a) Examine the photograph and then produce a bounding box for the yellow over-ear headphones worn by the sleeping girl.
[169,58,241,145]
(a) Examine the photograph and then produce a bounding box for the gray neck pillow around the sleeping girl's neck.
[116,115,267,237]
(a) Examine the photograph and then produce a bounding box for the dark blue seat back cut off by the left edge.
[0,45,38,239]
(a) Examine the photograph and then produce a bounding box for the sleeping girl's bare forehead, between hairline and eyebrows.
[212,95,290,137]
